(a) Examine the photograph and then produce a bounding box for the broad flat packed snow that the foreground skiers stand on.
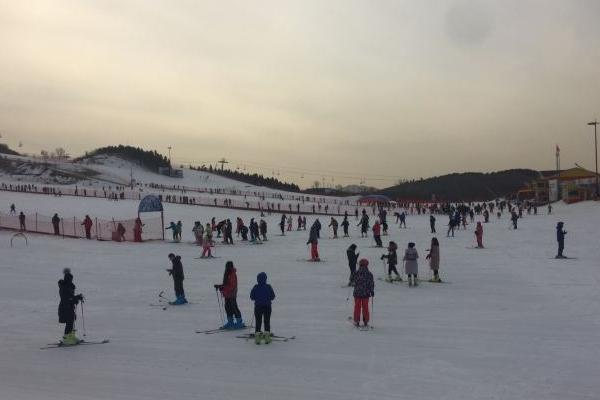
[0,193,600,400]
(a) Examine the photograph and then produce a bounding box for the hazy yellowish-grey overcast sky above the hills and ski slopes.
[0,0,600,186]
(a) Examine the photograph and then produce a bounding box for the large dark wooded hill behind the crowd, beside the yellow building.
[377,169,539,201]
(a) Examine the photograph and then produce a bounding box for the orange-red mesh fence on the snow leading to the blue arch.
[0,213,163,242]
